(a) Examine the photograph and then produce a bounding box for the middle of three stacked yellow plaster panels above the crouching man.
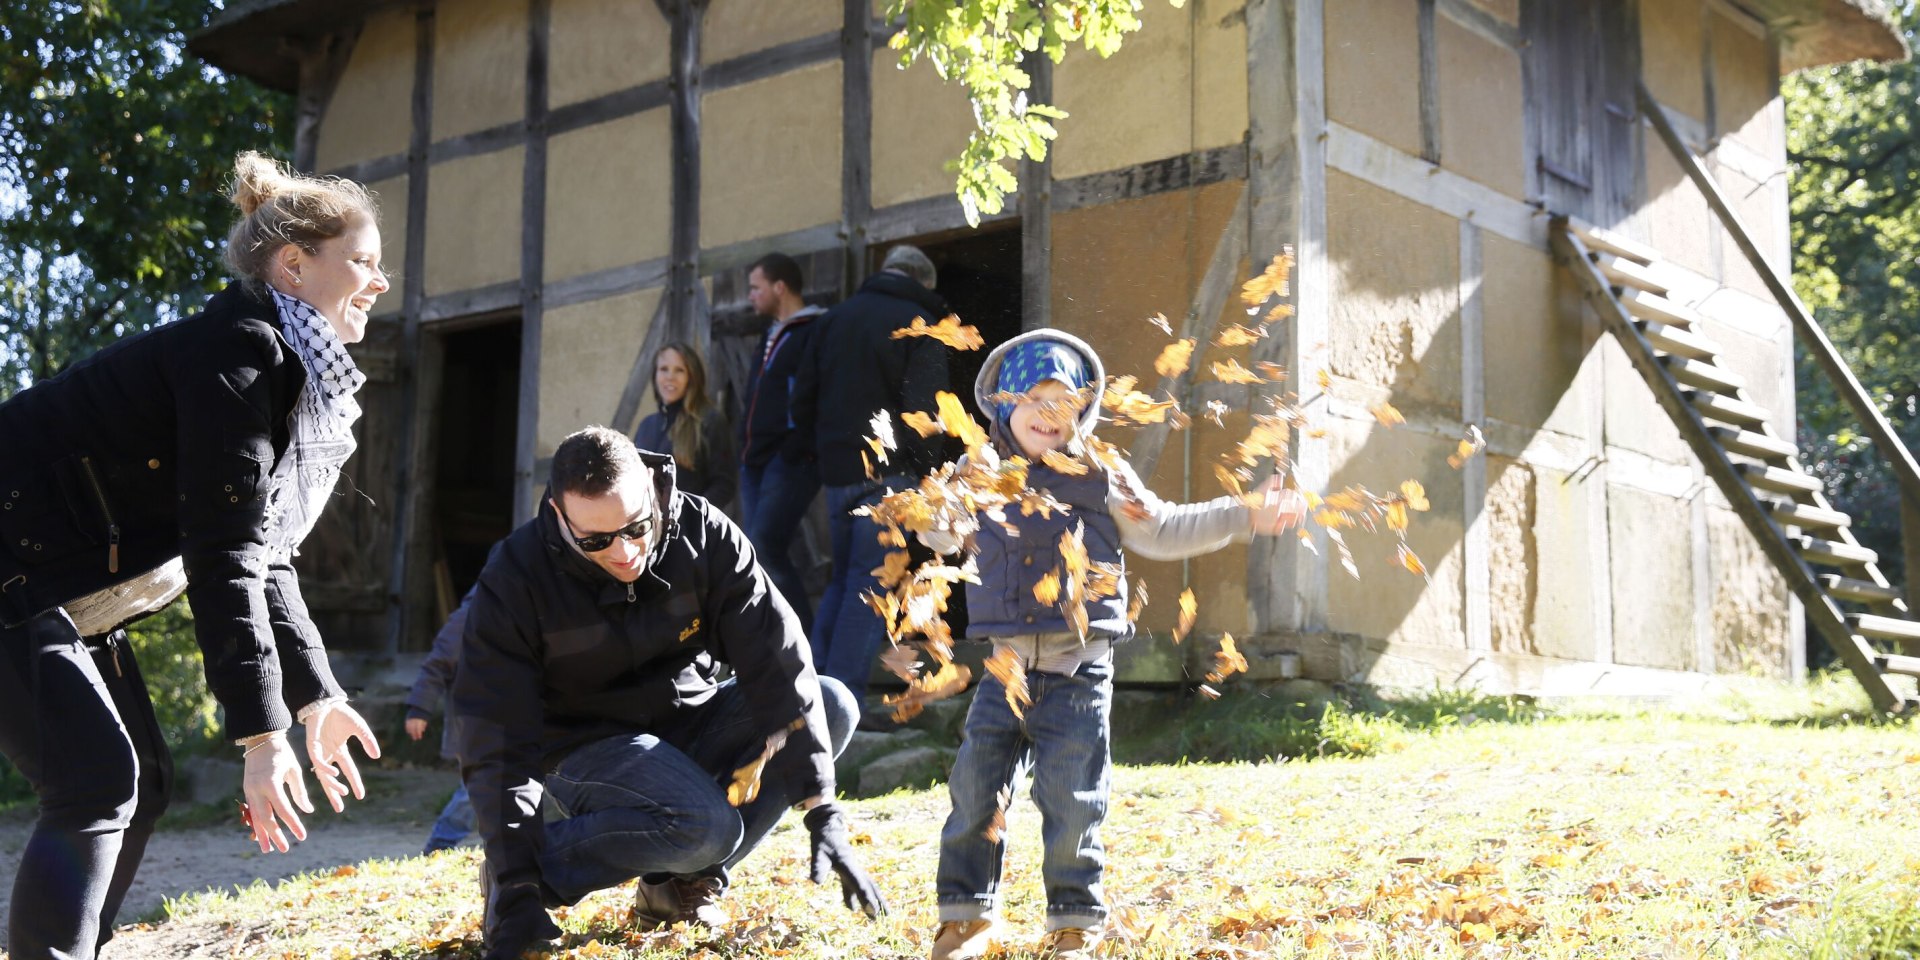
[545,108,674,280]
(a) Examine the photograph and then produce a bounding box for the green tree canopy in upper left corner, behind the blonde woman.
[0,0,292,397]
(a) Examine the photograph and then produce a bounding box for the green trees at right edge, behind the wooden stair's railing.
[1782,0,1920,582]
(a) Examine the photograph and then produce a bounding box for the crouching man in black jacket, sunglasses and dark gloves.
[449,426,885,960]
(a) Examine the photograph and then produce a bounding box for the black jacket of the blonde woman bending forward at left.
[0,286,340,737]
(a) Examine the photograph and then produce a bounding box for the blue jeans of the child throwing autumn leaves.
[937,659,1114,929]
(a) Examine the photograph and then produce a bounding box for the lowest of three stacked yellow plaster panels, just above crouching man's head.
[534,288,660,457]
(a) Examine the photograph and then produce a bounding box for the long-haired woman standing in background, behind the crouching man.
[634,344,739,509]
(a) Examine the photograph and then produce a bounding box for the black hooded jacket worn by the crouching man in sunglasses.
[449,453,833,937]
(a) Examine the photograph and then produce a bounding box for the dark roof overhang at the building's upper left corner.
[186,0,401,92]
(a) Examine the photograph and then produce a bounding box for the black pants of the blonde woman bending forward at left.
[0,611,173,960]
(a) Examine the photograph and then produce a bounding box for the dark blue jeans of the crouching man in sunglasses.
[540,678,858,902]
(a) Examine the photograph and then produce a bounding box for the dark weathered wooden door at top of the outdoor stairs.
[1521,0,1640,227]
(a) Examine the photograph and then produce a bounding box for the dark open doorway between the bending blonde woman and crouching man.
[428,317,520,622]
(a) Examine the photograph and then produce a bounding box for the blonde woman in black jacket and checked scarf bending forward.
[0,154,388,958]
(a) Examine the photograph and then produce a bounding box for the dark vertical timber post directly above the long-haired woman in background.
[664,0,707,340]
